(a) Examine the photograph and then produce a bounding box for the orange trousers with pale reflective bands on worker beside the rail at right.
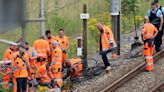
[143,42,154,71]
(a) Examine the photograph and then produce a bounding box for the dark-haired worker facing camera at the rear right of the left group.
[57,29,69,66]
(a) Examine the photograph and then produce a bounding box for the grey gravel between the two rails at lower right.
[115,58,164,92]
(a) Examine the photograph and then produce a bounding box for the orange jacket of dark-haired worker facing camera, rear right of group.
[57,36,69,50]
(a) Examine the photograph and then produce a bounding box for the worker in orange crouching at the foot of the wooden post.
[66,58,83,80]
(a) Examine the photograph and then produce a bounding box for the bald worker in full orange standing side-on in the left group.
[50,41,63,88]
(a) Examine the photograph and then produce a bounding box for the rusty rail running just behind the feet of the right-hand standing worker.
[101,50,164,92]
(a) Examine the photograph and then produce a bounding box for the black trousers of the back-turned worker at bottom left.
[16,78,27,92]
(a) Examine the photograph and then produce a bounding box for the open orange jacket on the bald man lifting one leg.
[98,26,115,51]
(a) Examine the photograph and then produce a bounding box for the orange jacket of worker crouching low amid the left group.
[37,65,51,83]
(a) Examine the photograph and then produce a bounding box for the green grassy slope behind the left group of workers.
[0,0,109,60]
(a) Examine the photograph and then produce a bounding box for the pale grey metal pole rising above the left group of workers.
[40,0,45,36]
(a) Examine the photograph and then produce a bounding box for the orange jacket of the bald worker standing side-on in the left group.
[52,47,63,66]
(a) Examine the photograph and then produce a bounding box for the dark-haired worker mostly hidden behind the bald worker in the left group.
[45,30,57,63]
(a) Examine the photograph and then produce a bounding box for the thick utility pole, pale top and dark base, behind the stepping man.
[110,0,120,55]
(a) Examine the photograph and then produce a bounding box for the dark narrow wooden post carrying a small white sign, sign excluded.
[83,4,88,71]
